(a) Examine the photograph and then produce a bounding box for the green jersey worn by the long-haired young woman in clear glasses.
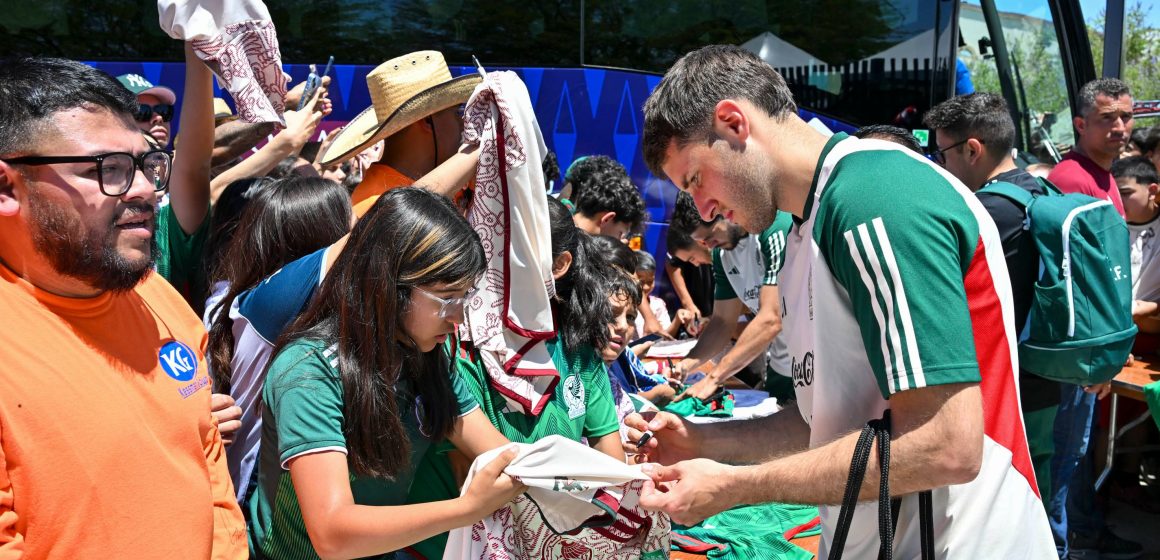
[249,340,478,560]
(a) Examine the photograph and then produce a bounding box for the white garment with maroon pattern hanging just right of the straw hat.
[461,72,560,415]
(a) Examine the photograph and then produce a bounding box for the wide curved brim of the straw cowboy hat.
[321,74,483,166]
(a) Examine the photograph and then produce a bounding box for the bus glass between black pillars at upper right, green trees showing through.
[959,0,1075,162]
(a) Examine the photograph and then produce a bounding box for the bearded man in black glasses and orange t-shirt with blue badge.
[0,58,247,559]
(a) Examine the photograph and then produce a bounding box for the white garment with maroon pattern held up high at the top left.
[157,0,288,126]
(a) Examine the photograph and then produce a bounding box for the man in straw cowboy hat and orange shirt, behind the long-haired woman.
[321,51,481,217]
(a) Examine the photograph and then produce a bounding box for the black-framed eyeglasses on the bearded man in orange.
[3,150,173,196]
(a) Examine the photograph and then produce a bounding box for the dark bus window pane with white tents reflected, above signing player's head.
[583,0,955,129]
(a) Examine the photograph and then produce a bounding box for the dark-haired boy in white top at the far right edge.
[1111,155,1160,334]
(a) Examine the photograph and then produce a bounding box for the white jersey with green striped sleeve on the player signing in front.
[778,134,1056,559]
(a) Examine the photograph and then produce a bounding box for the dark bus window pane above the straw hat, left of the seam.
[0,0,580,66]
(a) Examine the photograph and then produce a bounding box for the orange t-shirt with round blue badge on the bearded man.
[0,264,248,560]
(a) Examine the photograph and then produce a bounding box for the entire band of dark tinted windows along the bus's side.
[0,0,957,133]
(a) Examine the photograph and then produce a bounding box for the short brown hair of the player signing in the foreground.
[644,45,797,177]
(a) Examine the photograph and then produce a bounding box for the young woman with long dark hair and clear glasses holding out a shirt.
[248,188,523,559]
